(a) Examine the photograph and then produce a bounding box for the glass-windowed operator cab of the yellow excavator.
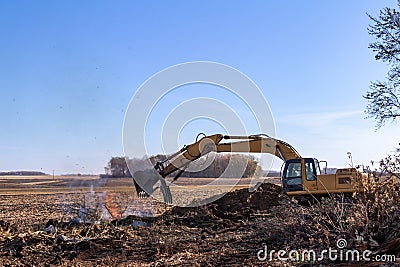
[282,158,321,192]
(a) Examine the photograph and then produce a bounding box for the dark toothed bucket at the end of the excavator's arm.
[133,169,172,204]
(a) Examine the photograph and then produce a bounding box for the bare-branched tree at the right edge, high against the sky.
[364,2,400,128]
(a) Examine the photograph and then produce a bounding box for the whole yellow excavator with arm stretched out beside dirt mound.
[133,134,358,204]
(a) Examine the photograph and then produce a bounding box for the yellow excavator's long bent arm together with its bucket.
[133,134,300,203]
